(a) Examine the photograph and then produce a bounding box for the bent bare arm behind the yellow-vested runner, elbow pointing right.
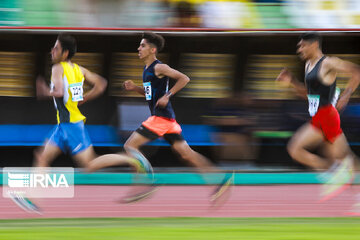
[80,67,107,103]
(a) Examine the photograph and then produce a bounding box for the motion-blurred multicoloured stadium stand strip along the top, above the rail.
[0,0,360,28]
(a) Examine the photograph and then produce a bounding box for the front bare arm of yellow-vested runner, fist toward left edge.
[36,63,64,97]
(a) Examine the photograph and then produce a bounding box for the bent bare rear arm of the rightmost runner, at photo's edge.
[322,57,360,110]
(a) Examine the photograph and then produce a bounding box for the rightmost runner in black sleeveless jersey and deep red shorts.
[277,33,360,200]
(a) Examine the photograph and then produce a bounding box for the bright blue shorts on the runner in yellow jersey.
[49,121,91,155]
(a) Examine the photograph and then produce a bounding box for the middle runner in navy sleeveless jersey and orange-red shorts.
[88,32,233,203]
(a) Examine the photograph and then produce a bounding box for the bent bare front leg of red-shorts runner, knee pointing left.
[287,123,331,171]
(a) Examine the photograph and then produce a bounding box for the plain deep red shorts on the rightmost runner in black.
[311,105,343,143]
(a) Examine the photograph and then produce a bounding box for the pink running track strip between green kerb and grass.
[0,185,360,219]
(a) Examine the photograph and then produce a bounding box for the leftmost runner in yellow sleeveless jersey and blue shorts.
[12,34,149,212]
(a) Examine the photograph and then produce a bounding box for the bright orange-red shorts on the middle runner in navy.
[142,116,182,137]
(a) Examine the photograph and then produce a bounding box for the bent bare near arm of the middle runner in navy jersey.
[155,64,190,107]
